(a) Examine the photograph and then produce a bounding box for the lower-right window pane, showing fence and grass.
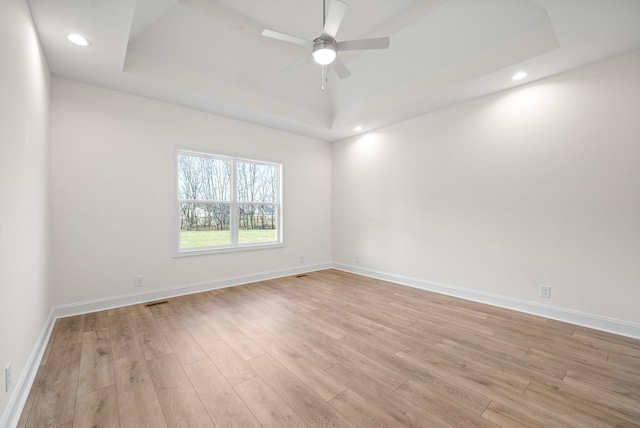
[238,205,278,244]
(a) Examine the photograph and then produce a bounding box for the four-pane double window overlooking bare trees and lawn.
[177,150,282,254]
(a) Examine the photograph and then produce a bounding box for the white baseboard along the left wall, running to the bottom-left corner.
[0,308,55,428]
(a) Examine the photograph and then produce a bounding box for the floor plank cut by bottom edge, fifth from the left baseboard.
[184,358,261,428]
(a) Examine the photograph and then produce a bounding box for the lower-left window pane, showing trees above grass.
[180,203,231,248]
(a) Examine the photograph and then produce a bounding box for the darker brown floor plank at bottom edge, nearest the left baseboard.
[26,343,82,428]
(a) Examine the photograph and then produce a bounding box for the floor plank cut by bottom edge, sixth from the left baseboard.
[234,377,308,428]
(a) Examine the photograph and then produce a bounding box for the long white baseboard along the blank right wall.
[332,263,640,339]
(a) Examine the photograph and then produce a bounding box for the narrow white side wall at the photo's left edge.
[0,0,51,425]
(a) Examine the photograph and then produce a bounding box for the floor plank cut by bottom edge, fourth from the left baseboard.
[147,354,214,428]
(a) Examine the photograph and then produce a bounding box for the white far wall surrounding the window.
[51,78,331,305]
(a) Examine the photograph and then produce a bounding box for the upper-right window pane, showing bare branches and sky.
[237,162,278,202]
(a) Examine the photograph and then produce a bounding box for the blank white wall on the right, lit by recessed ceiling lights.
[332,52,640,324]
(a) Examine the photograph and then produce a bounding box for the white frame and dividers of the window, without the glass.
[172,146,284,257]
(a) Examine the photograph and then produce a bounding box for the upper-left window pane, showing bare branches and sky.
[178,154,231,201]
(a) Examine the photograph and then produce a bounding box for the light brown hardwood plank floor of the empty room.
[19,270,640,428]
